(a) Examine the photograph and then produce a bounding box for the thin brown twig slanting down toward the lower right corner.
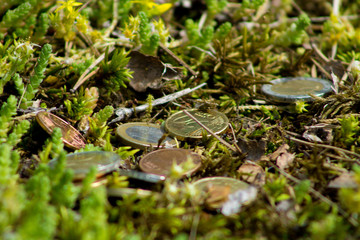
[270,162,359,227]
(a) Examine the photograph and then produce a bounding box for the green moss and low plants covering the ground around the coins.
[0,0,360,240]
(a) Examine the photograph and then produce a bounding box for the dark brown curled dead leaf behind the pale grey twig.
[127,51,181,92]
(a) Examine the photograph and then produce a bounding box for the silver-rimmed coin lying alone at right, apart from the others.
[261,77,332,103]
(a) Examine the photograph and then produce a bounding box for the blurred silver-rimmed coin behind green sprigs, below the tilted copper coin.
[49,151,121,180]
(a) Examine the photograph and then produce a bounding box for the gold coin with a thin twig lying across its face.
[165,109,229,140]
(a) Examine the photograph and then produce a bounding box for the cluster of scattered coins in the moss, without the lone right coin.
[36,109,256,212]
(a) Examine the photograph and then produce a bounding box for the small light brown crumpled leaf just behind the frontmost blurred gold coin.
[237,163,265,186]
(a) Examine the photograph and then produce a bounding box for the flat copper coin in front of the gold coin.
[139,148,201,176]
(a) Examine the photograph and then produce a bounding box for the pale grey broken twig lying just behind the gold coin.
[109,83,206,124]
